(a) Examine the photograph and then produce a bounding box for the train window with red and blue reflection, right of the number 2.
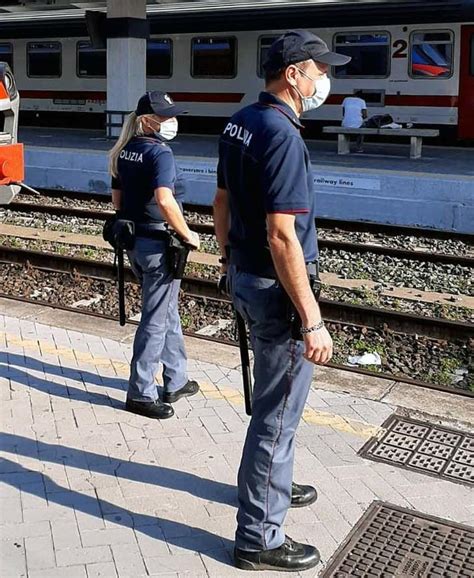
[410,30,454,78]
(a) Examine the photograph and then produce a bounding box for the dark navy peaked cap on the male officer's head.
[263,30,351,72]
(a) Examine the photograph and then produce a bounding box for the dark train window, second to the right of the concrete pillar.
[191,36,237,78]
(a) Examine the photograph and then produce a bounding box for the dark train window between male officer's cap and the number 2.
[333,32,390,78]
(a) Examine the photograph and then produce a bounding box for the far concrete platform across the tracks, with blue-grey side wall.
[19,128,474,233]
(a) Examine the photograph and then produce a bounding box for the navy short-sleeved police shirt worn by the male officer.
[217,92,318,278]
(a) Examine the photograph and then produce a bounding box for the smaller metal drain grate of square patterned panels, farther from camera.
[359,415,474,485]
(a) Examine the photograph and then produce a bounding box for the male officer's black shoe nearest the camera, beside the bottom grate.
[234,536,320,572]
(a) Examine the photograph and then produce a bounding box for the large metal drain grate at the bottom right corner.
[321,502,474,578]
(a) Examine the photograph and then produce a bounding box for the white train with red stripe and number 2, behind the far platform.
[0,0,474,139]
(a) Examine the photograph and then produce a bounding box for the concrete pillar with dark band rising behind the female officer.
[106,0,148,138]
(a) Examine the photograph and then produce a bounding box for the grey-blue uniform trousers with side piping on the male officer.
[228,266,313,550]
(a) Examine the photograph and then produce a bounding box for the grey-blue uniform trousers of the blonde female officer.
[127,237,188,401]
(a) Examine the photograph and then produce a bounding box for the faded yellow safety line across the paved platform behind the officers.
[0,332,381,438]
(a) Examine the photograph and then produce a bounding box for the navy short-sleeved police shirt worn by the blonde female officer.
[112,136,186,229]
